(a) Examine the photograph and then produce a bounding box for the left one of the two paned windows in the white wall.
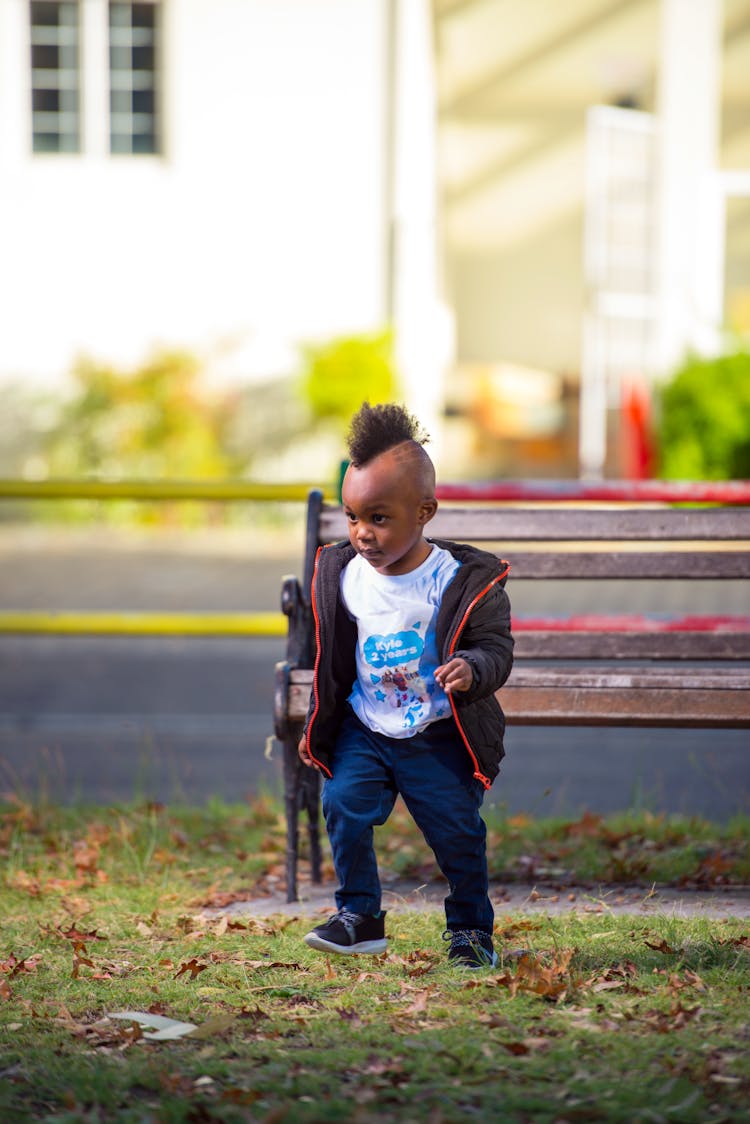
[30,0,81,152]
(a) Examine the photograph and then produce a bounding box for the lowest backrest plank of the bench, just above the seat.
[514,629,750,660]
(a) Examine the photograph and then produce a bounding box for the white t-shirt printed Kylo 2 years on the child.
[341,545,460,737]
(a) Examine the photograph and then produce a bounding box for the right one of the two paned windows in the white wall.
[109,0,159,153]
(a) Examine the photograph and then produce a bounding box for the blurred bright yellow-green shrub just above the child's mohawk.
[300,330,398,423]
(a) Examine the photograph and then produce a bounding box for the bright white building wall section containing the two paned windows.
[0,0,393,391]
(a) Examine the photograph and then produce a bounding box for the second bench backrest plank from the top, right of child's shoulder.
[508,546,750,581]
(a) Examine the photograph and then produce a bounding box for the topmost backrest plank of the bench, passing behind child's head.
[319,505,750,543]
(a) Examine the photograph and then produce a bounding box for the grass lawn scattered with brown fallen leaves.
[0,800,750,1124]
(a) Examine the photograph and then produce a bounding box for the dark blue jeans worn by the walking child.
[323,711,494,933]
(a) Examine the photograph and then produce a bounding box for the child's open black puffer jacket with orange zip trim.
[305,538,513,788]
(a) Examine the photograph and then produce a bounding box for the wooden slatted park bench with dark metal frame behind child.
[274,482,750,901]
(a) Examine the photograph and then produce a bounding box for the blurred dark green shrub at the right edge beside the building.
[658,348,750,480]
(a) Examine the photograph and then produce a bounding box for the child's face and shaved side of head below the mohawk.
[342,450,437,574]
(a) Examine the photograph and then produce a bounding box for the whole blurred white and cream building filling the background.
[0,0,750,471]
